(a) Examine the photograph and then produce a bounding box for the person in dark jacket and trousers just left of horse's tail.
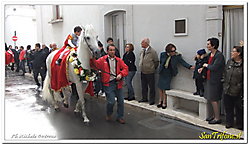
[31,43,47,90]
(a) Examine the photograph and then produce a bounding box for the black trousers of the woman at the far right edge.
[224,94,243,128]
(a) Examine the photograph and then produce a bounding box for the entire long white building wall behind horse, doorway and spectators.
[38,5,222,96]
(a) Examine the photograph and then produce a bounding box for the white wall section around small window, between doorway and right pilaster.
[133,5,207,92]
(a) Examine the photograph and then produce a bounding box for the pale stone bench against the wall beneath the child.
[165,90,208,120]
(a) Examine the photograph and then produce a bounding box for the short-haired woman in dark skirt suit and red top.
[198,38,225,124]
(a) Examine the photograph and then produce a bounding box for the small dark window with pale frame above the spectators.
[174,18,188,36]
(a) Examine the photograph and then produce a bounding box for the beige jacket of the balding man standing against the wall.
[139,46,159,74]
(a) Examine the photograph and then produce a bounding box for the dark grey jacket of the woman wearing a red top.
[204,50,225,85]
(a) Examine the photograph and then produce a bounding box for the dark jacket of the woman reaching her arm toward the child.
[159,52,191,76]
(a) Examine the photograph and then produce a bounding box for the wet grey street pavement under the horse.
[4,71,218,142]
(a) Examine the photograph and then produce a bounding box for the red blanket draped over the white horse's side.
[51,47,70,91]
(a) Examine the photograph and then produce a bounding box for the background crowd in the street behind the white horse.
[6,43,59,89]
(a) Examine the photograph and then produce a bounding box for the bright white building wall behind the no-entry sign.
[4,5,37,48]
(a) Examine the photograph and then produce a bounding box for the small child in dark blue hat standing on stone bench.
[193,49,207,97]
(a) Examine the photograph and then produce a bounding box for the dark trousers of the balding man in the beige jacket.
[141,72,155,103]
